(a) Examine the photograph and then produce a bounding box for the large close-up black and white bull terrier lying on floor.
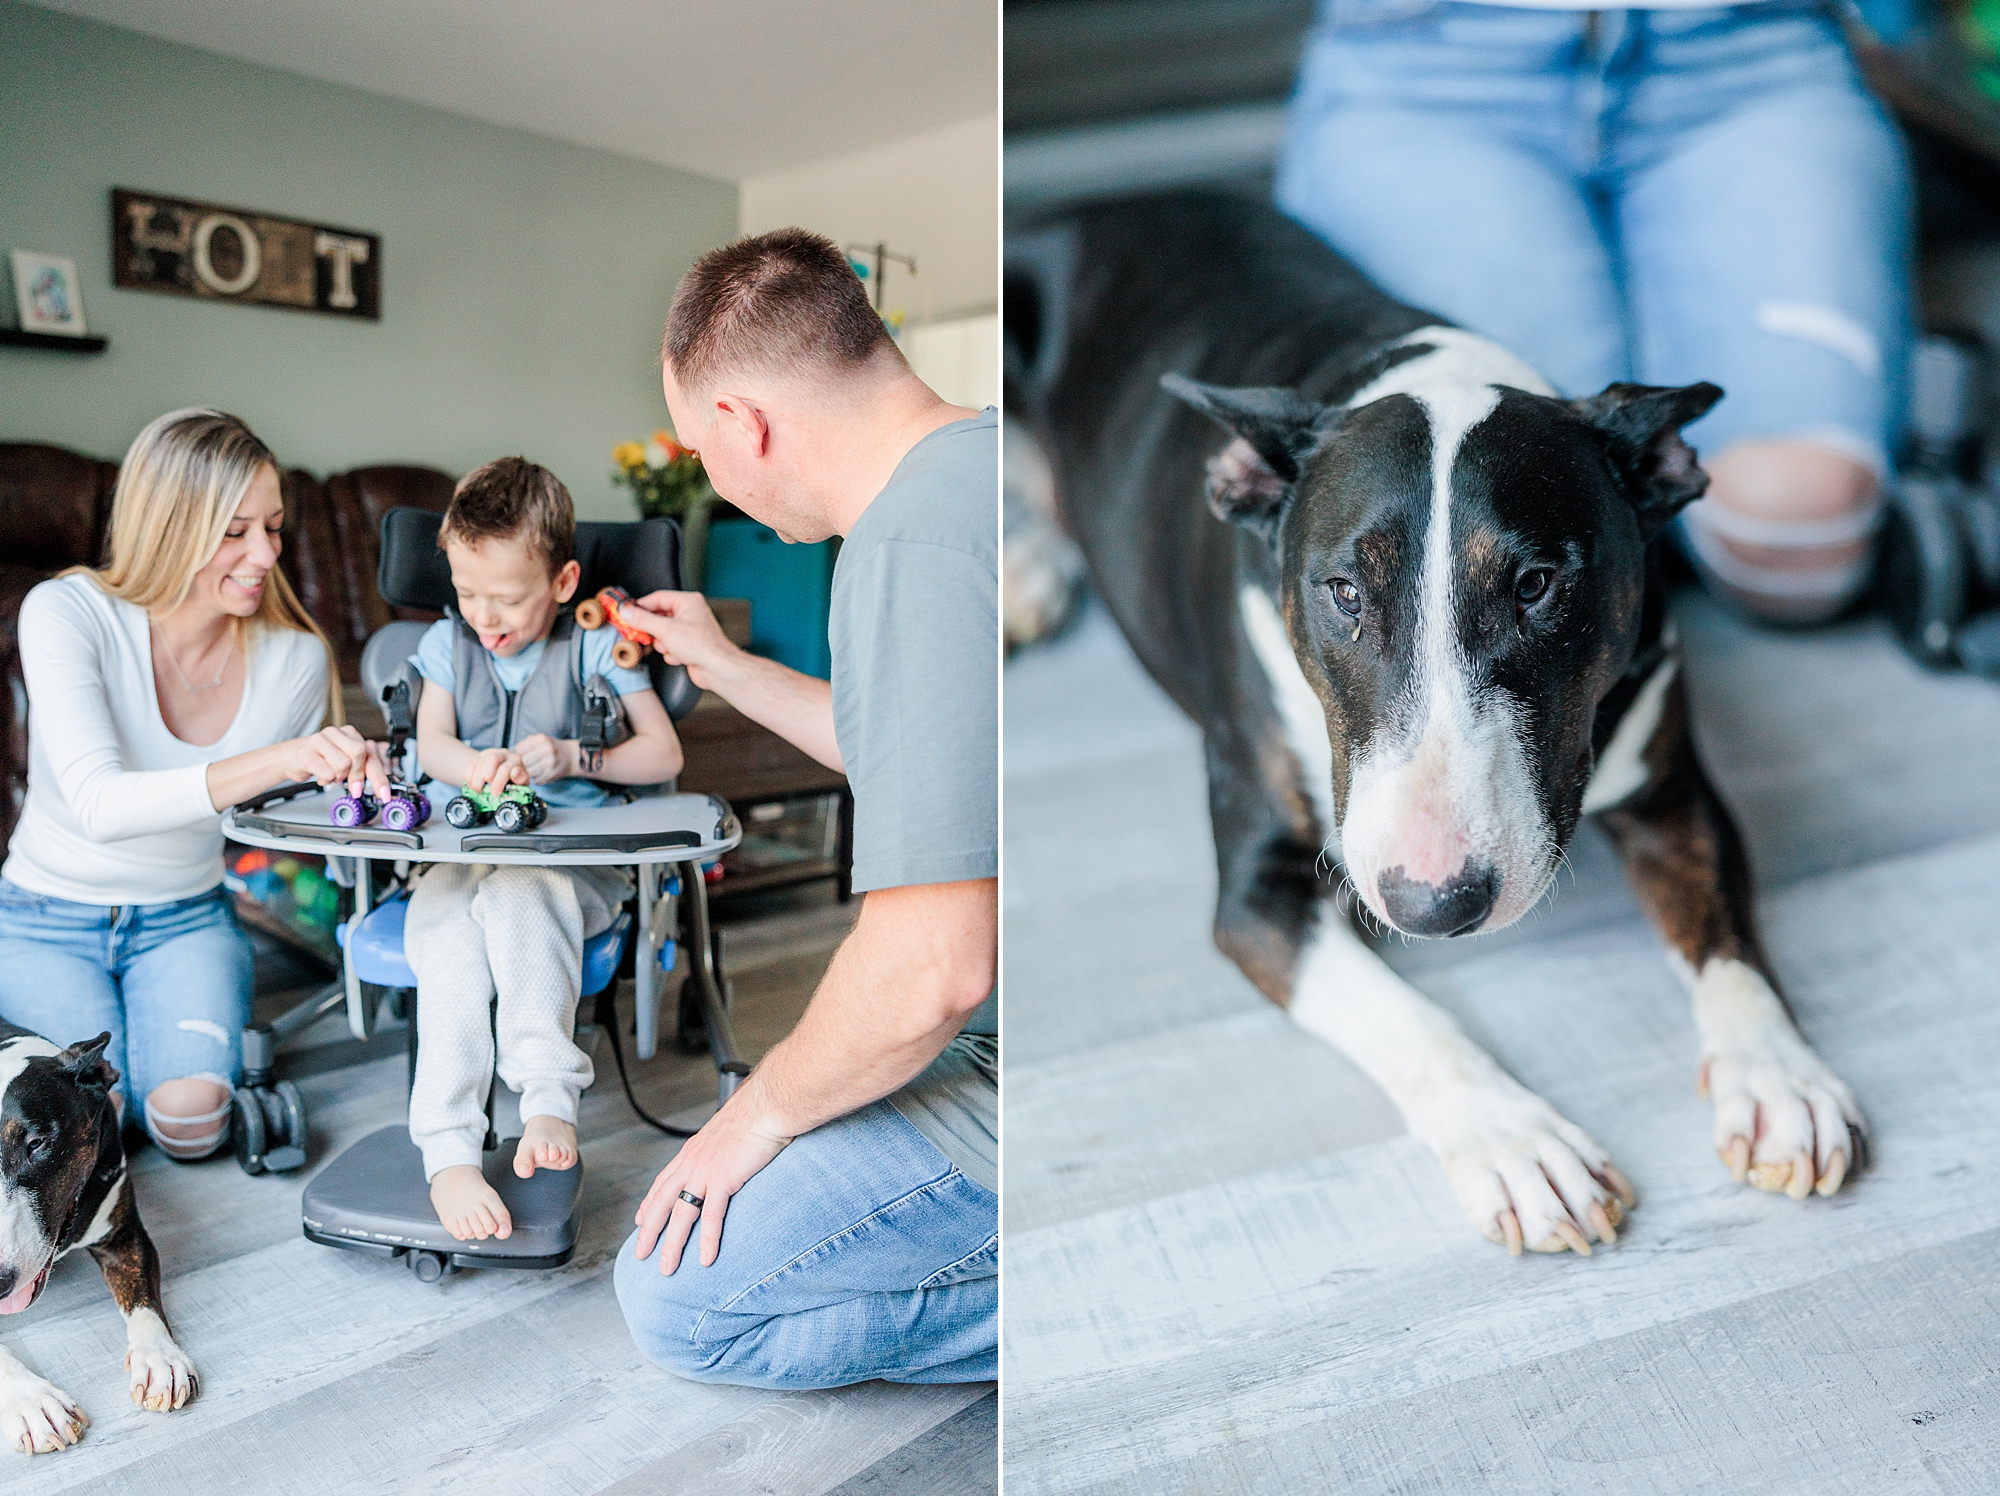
[1006,194,1866,1254]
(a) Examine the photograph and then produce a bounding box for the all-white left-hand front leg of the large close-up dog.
[1288,900,1638,1256]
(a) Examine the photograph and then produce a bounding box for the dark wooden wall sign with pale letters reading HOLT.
[112,188,382,322]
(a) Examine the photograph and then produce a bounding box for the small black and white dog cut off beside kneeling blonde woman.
[0,1024,196,1454]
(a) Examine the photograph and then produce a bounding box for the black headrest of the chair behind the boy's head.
[376,508,702,718]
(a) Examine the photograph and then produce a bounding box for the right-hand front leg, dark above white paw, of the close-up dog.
[1602,666,1868,1200]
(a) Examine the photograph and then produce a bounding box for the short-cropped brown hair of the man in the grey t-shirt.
[660,228,902,390]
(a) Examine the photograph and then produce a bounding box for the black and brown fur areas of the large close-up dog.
[1006,194,1862,1230]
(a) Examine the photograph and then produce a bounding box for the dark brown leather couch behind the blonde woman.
[0,442,454,856]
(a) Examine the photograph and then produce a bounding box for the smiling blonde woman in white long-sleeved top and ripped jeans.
[0,410,384,1158]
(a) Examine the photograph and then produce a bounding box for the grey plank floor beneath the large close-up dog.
[1002,594,2000,1496]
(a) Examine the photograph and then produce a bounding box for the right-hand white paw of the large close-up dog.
[1696,1024,1868,1200]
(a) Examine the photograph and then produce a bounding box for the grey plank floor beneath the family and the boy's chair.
[0,904,996,1496]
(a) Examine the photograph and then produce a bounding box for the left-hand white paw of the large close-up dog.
[1418,1078,1638,1256]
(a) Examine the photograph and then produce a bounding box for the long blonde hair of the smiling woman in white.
[64,408,344,722]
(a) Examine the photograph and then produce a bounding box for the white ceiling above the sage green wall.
[34,0,1000,182]
